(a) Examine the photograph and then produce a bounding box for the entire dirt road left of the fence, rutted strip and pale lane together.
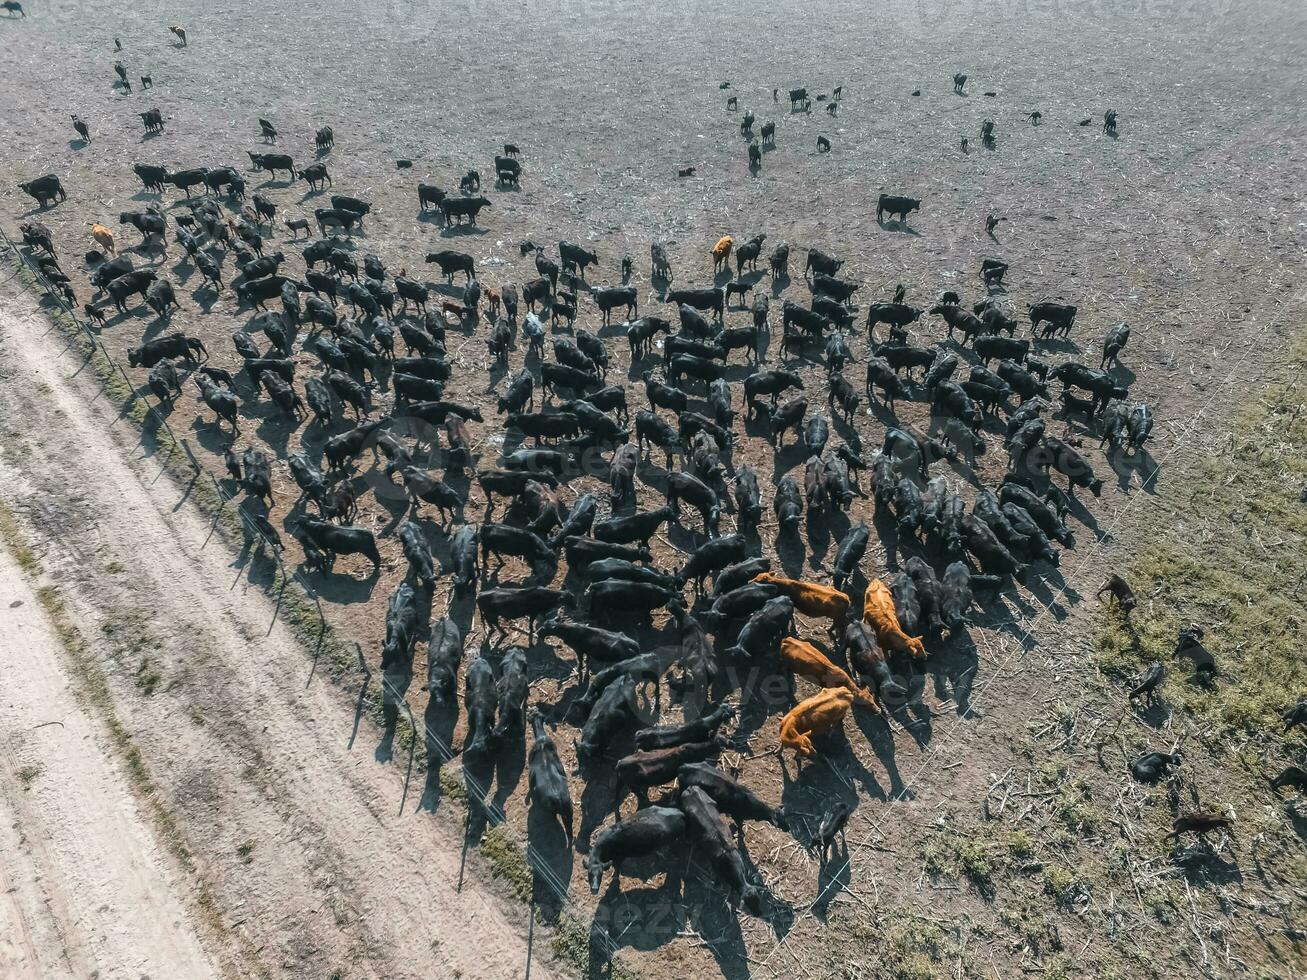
[0,286,554,977]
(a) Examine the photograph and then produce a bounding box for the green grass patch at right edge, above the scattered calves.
[1094,344,1307,740]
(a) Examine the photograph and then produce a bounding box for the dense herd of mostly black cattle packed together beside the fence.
[21,48,1291,930]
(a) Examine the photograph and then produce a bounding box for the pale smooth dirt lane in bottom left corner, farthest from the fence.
[0,550,217,980]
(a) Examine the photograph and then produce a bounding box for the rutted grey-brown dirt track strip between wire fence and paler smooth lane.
[0,286,554,977]
